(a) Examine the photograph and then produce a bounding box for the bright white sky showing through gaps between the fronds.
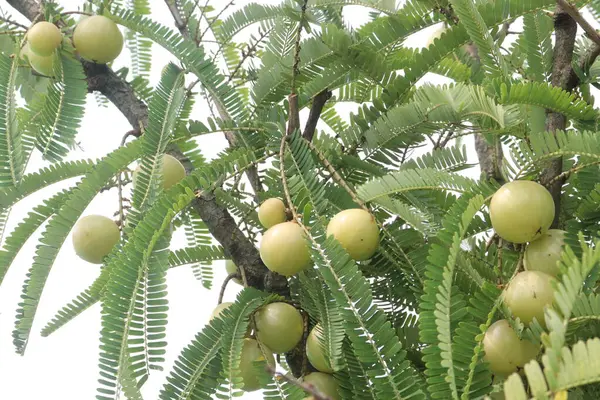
[0,0,478,400]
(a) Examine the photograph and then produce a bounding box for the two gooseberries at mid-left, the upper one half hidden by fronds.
[73,154,185,264]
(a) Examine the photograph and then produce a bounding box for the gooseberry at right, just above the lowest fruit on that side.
[504,271,554,326]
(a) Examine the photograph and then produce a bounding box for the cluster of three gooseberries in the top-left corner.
[21,15,123,76]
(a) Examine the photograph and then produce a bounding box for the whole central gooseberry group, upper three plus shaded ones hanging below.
[211,198,379,400]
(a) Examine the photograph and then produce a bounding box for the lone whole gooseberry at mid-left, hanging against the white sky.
[73,215,121,264]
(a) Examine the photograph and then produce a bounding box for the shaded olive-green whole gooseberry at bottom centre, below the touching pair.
[254,302,304,353]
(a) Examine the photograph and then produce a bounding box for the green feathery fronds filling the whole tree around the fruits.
[0,0,600,400]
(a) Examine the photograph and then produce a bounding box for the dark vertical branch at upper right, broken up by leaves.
[540,2,579,228]
